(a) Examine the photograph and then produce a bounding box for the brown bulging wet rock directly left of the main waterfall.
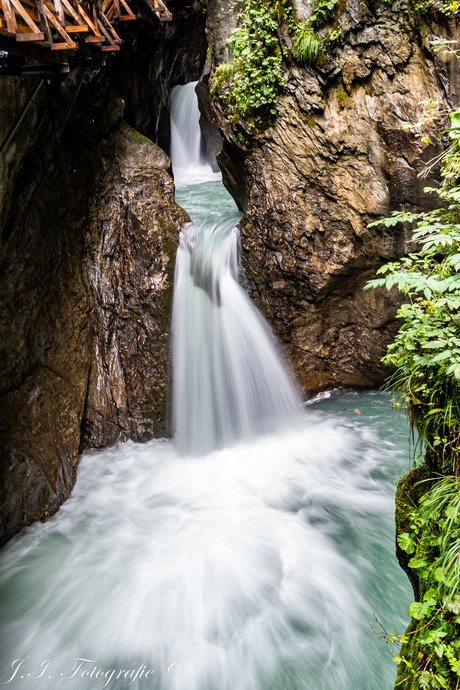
[80,126,188,450]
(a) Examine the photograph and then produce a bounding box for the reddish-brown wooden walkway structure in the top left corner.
[0,0,172,56]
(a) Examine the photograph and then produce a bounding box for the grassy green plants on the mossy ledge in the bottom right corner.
[392,476,460,688]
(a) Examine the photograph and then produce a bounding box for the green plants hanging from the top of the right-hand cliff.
[223,0,287,119]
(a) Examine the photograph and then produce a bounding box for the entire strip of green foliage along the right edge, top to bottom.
[366,44,460,690]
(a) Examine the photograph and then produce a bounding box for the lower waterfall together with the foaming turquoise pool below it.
[0,82,411,690]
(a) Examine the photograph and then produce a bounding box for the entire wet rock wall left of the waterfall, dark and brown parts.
[0,70,187,543]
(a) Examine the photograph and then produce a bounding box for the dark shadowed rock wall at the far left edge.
[0,75,91,542]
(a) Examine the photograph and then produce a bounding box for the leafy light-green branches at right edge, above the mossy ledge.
[367,111,460,473]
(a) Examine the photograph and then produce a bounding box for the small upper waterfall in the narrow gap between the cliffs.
[171,82,220,187]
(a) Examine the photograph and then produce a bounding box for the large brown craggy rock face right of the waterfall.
[204,2,460,392]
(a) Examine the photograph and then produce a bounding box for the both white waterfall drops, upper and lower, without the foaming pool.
[171,84,300,454]
